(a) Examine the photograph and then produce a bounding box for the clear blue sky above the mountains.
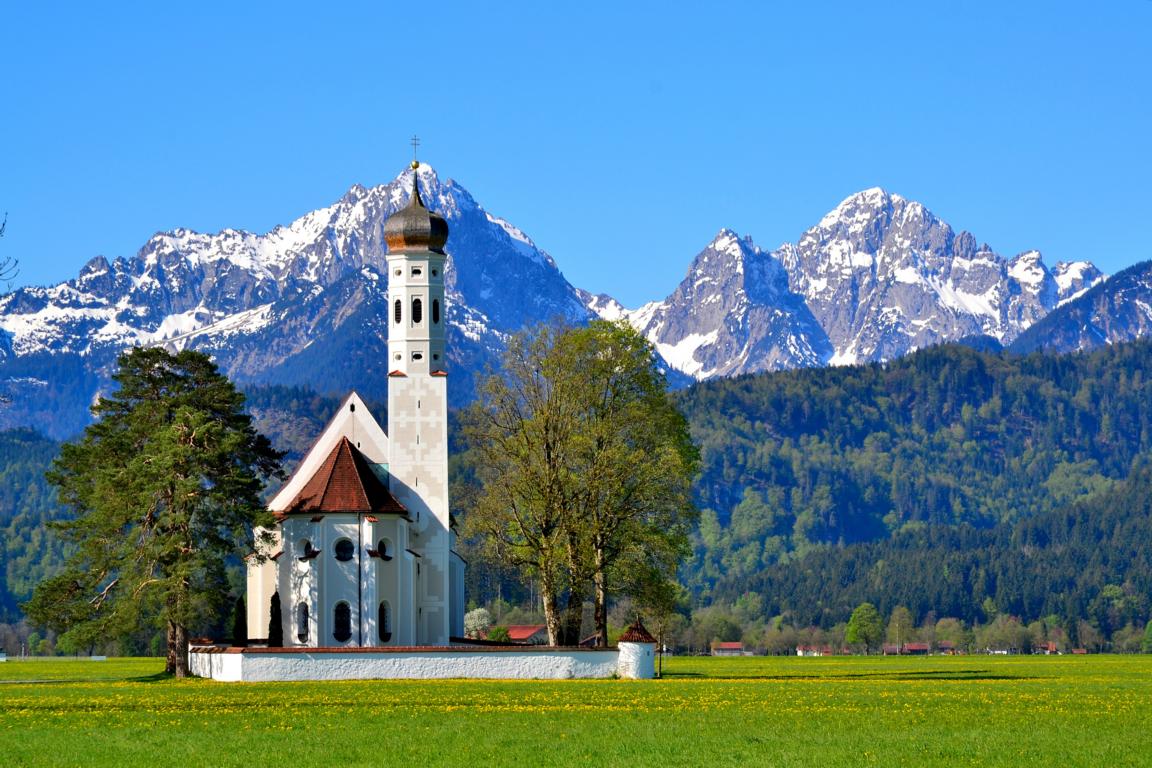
[0,0,1152,306]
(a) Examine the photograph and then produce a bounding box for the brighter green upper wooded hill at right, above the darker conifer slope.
[680,341,1152,599]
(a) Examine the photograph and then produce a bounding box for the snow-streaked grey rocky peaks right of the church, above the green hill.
[612,188,1104,379]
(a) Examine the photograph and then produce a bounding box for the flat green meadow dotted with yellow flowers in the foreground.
[0,656,1152,768]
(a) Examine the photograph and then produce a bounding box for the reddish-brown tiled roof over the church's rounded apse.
[285,438,408,515]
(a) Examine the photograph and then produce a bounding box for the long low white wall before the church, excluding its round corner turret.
[190,649,619,682]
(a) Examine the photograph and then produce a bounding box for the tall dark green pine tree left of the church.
[24,348,281,677]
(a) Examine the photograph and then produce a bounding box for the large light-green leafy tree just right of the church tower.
[462,321,698,645]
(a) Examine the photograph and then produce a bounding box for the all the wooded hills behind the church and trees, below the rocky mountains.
[0,341,1152,648]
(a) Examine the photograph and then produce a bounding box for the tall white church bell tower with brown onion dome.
[384,161,452,645]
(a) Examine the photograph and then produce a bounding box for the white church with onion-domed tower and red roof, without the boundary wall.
[247,162,464,648]
